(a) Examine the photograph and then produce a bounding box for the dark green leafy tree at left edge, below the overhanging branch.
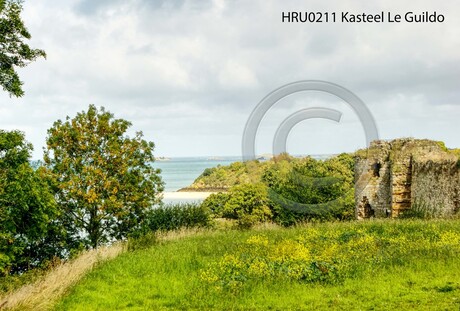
[0,131,63,275]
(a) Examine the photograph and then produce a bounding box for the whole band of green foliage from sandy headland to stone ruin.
[199,154,354,226]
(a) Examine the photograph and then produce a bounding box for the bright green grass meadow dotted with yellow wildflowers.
[56,220,460,310]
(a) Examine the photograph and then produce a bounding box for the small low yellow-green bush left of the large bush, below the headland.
[202,183,272,228]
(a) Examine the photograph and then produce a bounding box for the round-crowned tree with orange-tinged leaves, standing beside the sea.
[44,105,163,247]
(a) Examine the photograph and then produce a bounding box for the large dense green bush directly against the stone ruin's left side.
[262,153,354,225]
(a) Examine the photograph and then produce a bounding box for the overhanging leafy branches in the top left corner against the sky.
[0,0,46,97]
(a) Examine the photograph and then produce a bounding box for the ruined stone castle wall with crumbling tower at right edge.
[355,139,460,219]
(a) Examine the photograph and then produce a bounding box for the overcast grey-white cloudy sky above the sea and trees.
[0,0,460,158]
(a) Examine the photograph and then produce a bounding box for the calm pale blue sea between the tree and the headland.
[153,157,241,192]
